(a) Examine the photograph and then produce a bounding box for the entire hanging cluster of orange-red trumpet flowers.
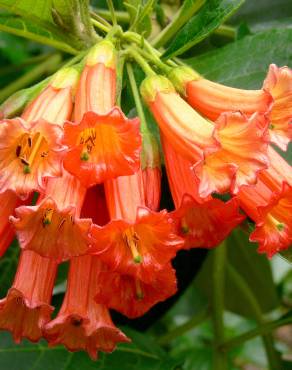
[0,40,292,358]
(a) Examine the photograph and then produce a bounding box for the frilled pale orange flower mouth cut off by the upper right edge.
[263,64,292,150]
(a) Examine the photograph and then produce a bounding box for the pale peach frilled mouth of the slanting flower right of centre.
[194,112,269,197]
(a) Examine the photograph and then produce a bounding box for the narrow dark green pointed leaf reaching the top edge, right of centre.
[163,0,244,58]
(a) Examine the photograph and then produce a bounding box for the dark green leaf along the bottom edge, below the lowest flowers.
[0,330,178,370]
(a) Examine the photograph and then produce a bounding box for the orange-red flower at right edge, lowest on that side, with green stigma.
[238,148,292,257]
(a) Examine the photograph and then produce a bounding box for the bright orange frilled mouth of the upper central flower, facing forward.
[64,108,141,187]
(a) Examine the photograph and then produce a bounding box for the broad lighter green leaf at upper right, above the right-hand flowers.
[185,29,292,89]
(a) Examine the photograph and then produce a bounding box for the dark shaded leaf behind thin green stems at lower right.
[196,229,279,317]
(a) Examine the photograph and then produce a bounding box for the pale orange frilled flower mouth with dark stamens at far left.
[0,119,65,198]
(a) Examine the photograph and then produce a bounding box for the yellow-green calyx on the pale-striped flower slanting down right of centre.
[140,75,175,103]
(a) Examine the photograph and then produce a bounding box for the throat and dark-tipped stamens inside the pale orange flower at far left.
[15,132,48,174]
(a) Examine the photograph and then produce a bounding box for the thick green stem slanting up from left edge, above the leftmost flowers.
[0,54,62,102]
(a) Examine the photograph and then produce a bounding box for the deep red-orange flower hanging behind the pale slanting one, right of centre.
[162,136,244,248]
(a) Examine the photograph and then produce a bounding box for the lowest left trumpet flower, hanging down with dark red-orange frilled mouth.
[0,251,57,343]
